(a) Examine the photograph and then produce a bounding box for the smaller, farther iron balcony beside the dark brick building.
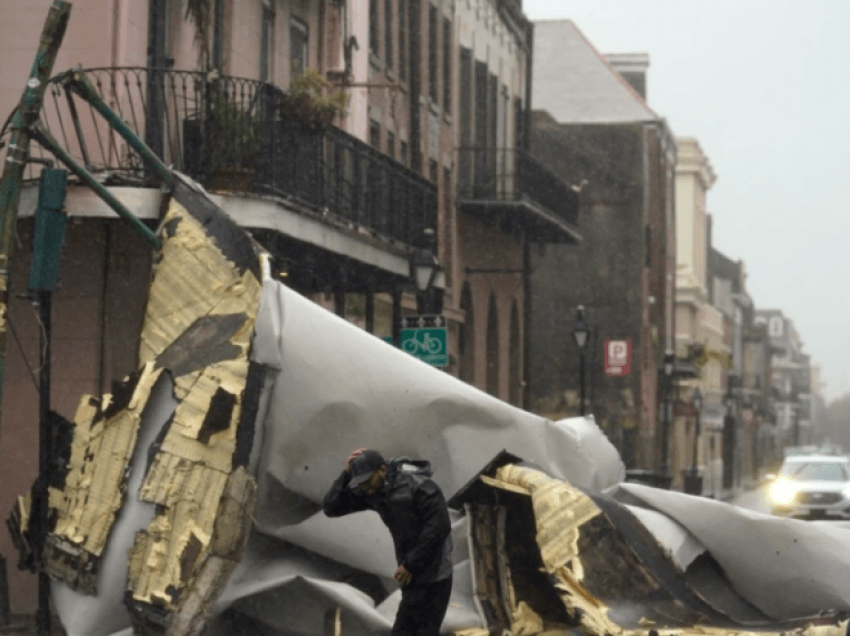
[458,148,581,243]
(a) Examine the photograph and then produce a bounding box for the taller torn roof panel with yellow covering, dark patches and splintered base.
[128,201,261,636]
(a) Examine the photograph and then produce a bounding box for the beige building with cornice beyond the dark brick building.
[670,137,731,492]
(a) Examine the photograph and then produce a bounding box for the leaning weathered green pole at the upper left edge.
[0,0,71,432]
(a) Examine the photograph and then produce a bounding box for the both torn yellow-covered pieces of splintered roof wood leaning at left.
[7,200,262,636]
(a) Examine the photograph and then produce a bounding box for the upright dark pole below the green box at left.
[33,290,52,636]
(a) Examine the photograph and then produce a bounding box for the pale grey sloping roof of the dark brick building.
[531,20,661,124]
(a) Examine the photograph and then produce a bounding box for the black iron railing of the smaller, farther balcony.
[458,147,578,231]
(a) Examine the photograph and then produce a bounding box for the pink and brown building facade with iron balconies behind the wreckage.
[0,0,578,611]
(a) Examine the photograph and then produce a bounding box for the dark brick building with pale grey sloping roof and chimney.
[531,21,676,472]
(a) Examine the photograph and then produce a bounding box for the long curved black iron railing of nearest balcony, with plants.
[33,68,437,247]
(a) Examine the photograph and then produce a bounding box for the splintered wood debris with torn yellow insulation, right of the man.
[454,464,848,636]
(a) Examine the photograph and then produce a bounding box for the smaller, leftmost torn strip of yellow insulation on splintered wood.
[50,364,161,556]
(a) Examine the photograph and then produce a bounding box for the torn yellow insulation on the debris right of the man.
[480,464,848,636]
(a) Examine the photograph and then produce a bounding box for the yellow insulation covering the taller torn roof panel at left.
[128,201,261,620]
